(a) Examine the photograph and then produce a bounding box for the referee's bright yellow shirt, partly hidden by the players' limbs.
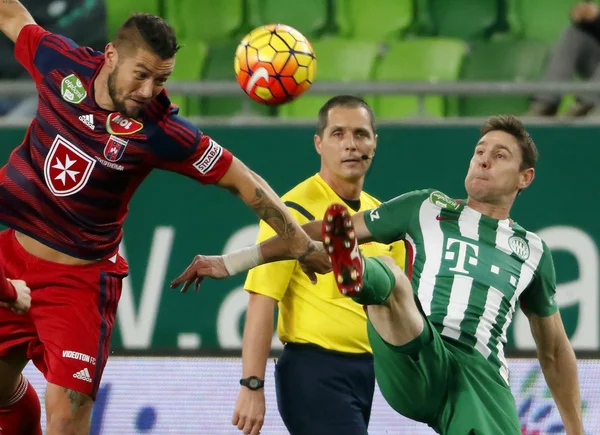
[244,174,405,353]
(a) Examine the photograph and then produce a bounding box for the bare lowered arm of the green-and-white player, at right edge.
[526,312,583,435]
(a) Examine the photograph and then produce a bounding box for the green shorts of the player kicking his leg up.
[368,318,521,435]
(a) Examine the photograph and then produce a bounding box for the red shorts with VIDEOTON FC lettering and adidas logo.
[0,229,128,399]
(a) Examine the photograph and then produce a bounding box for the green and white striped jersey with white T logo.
[365,189,557,382]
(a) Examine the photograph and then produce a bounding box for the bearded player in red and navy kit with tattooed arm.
[0,0,330,435]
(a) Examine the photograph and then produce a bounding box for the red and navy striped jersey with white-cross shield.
[0,24,233,259]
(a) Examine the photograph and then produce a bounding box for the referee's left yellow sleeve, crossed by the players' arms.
[244,209,308,301]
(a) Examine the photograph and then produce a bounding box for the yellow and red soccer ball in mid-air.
[234,24,317,105]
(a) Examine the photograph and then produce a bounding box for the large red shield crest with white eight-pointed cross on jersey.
[44,135,96,196]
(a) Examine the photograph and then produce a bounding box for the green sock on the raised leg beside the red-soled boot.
[352,257,396,305]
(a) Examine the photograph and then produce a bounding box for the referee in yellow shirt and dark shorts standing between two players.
[232,95,405,435]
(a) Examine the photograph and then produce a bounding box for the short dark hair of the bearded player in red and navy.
[113,13,181,60]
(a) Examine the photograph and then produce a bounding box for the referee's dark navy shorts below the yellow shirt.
[275,343,375,435]
